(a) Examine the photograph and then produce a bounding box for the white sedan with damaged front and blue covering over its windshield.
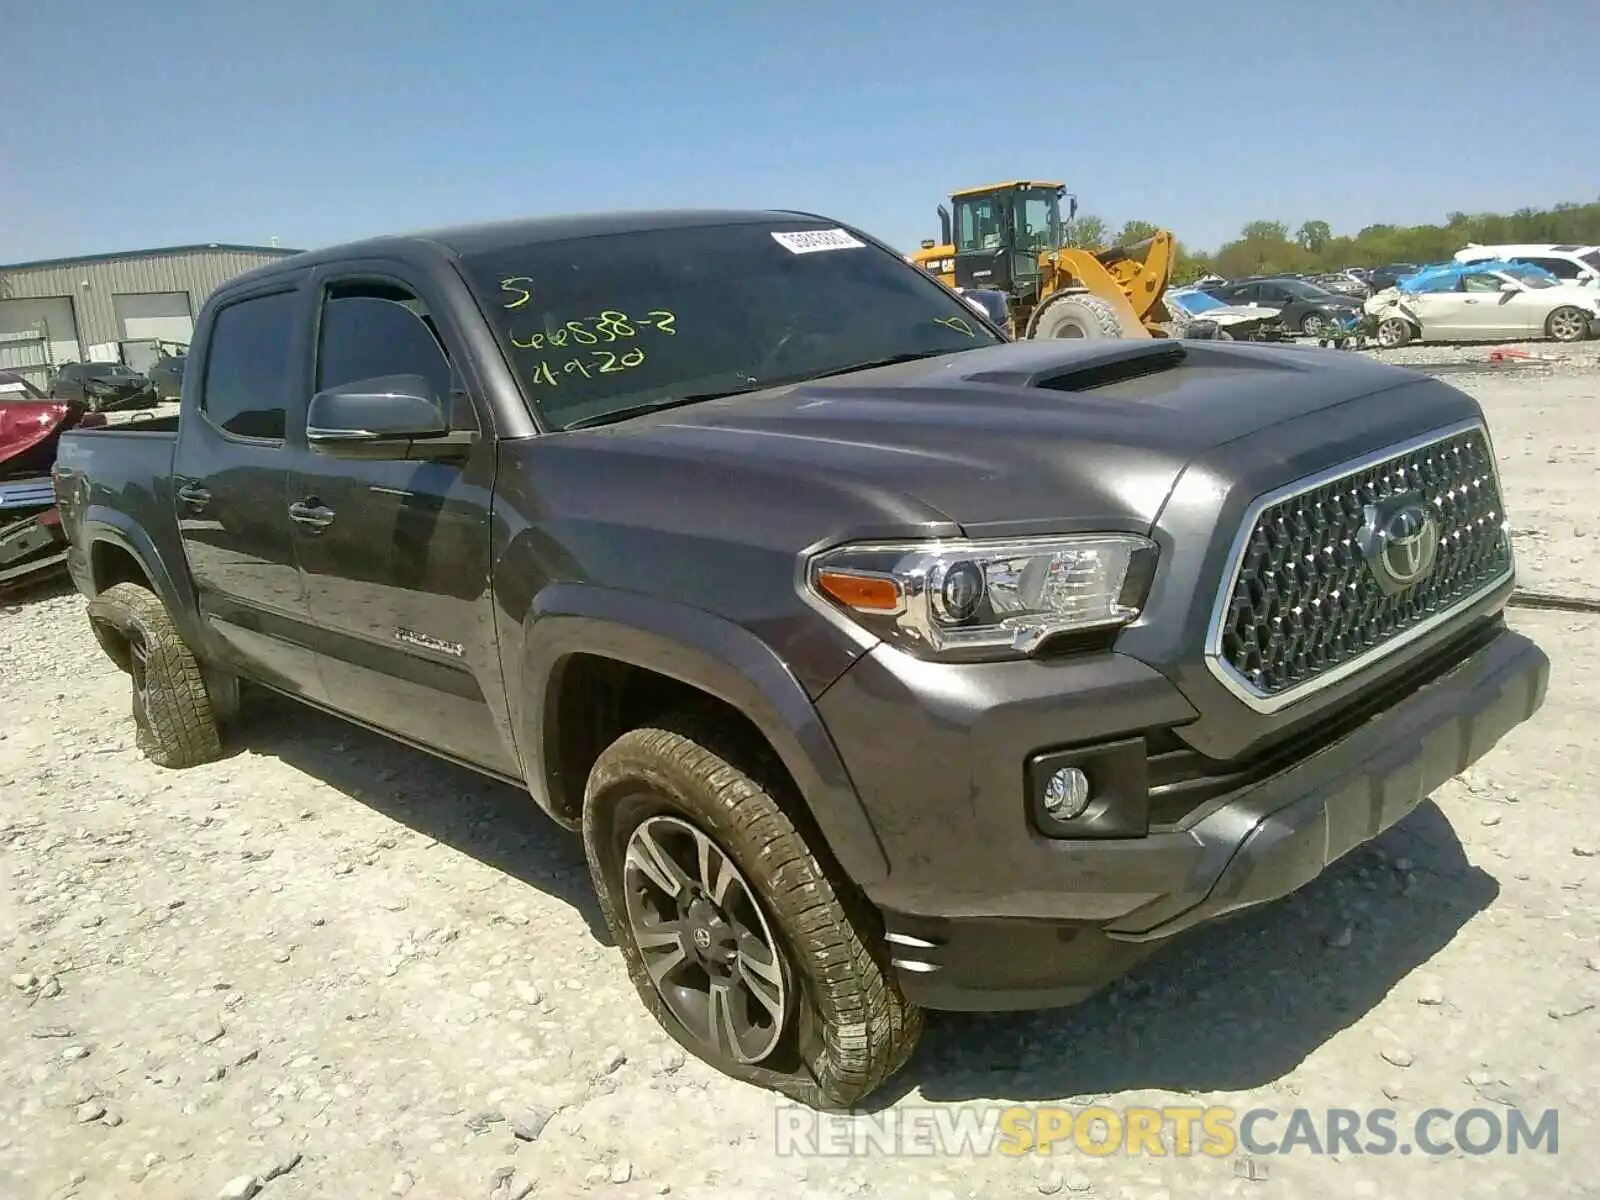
[1362,262,1600,347]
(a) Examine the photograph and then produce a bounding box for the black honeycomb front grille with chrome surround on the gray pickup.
[1208,424,1512,709]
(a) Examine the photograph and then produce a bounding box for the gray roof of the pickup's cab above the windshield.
[217,208,829,288]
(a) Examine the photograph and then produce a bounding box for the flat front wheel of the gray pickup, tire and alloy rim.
[582,715,922,1107]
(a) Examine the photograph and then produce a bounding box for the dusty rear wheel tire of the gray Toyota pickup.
[88,584,222,768]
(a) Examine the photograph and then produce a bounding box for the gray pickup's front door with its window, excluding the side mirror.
[290,272,520,776]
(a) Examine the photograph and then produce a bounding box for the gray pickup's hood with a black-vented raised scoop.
[563,339,1419,536]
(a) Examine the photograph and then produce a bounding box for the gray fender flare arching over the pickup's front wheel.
[510,582,888,886]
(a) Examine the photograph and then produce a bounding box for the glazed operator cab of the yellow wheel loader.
[950,182,1078,299]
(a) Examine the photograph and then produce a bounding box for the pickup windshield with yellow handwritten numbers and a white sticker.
[462,221,1003,427]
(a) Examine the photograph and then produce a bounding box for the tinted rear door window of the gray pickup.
[200,291,296,442]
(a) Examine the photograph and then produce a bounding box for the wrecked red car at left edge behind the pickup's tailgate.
[0,371,106,587]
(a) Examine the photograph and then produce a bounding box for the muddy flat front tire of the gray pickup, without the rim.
[582,712,922,1109]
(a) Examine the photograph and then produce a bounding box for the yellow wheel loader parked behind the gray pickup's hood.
[907,181,1174,338]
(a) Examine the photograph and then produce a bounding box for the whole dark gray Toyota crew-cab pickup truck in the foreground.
[56,211,1549,1107]
